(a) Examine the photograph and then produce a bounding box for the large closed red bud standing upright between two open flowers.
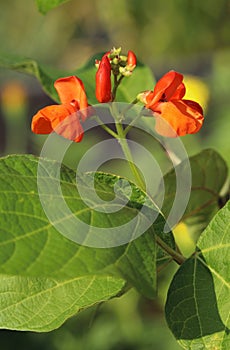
[96,53,112,103]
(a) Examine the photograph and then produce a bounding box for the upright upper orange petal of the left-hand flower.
[54,75,88,109]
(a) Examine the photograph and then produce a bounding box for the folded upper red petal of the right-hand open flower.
[146,71,185,108]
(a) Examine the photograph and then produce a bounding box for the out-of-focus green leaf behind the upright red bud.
[0,53,154,104]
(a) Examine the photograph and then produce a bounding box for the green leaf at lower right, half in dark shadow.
[165,202,230,349]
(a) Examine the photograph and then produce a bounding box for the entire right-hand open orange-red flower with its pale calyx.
[140,71,204,137]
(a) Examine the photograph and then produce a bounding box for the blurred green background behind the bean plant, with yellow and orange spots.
[0,0,230,350]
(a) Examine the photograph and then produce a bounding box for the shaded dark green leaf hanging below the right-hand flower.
[162,149,228,237]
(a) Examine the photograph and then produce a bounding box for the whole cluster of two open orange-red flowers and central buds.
[31,48,204,142]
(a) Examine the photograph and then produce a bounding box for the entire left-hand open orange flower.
[31,76,89,142]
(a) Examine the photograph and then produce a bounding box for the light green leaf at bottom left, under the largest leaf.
[0,275,125,332]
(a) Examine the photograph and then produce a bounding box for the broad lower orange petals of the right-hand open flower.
[154,100,204,137]
